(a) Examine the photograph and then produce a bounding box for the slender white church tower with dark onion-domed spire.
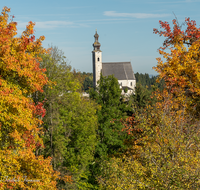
[92,30,102,87]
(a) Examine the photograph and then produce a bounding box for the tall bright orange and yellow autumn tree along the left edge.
[0,7,58,189]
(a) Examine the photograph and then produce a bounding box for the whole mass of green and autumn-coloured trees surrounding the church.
[0,7,200,190]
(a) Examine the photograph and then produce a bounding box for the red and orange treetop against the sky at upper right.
[154,18,200,115]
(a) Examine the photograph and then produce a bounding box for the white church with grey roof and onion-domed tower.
[92,31,136,94]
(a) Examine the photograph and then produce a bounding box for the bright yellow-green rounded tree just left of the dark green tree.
[59,93,97,172]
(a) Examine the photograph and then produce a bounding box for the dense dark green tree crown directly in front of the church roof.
[90,75,128,158]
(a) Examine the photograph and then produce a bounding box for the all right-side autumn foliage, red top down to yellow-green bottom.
[98,19,200,190]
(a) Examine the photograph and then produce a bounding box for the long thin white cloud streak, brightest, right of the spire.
[104,11,170,18]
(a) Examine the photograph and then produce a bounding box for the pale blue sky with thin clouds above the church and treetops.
[0,0,200,74]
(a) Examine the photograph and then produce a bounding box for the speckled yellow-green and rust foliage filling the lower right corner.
[98,97,200,189]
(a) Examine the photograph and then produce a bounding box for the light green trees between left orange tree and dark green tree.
[34,47,97,189]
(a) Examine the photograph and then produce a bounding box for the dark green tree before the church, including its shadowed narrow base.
[89,75,131,189]
